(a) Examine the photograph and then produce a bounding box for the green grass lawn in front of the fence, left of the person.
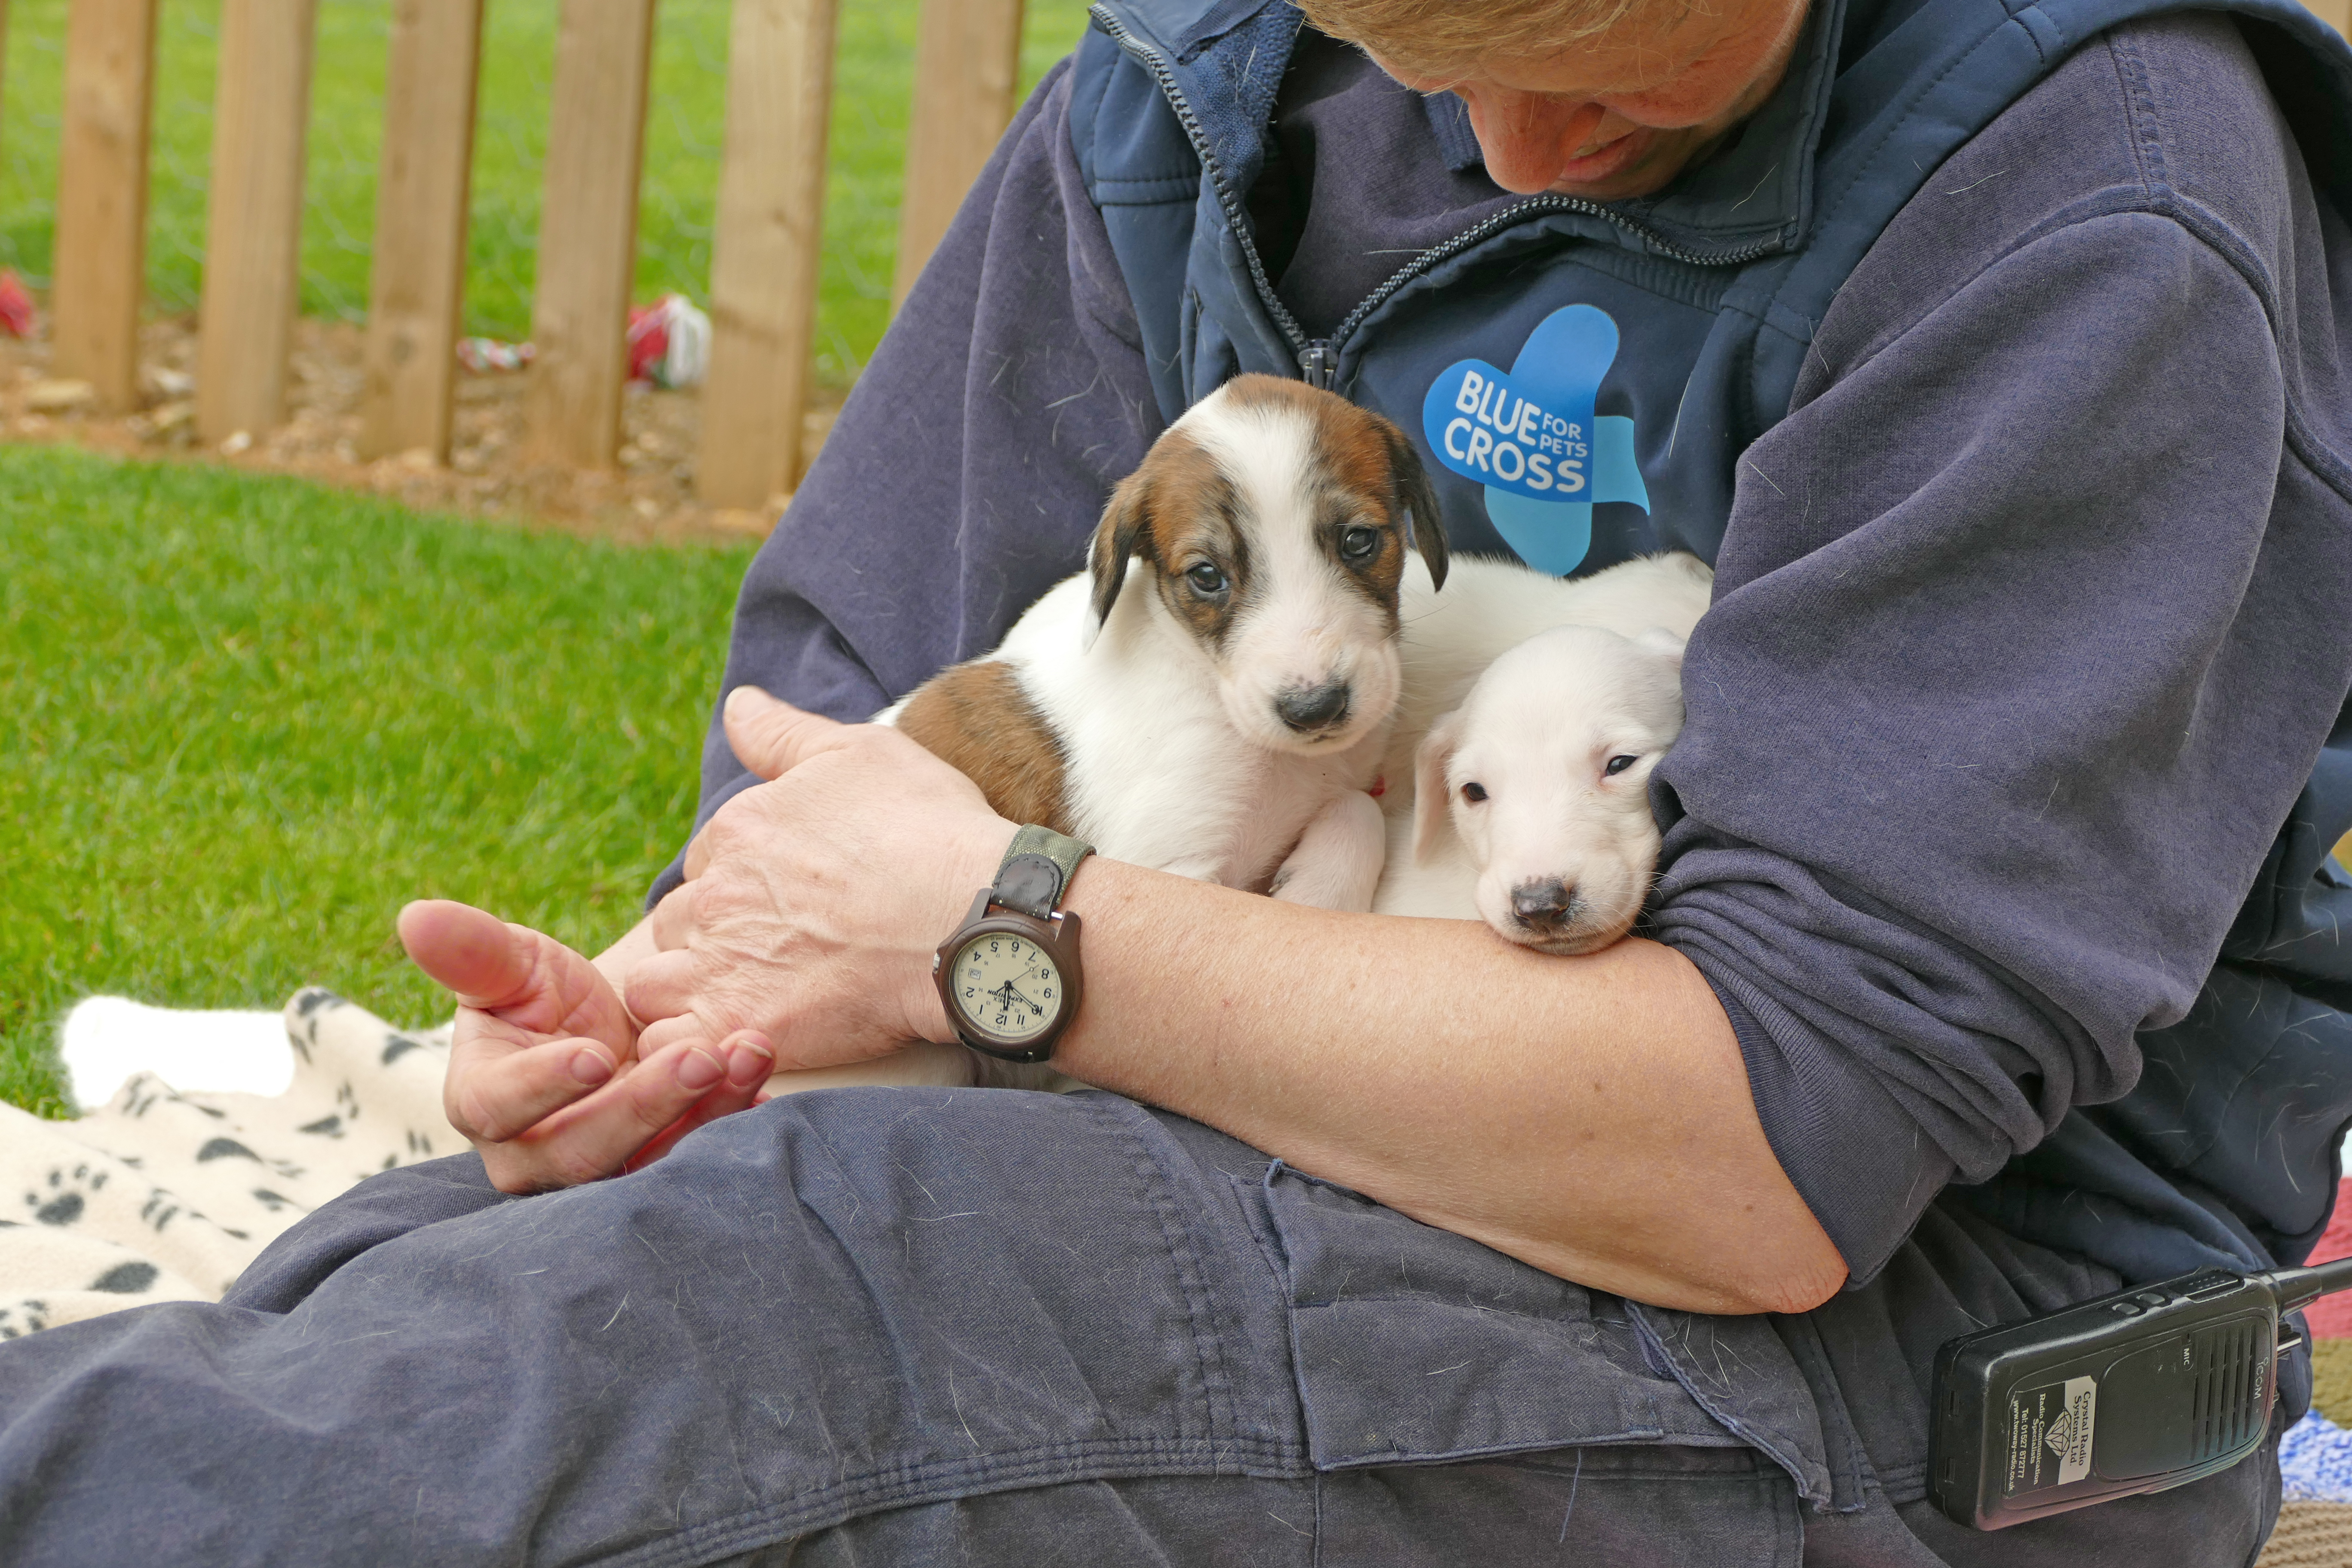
[0,447,750,1114]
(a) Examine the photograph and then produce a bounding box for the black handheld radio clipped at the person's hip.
[1929,1258,2352,1530]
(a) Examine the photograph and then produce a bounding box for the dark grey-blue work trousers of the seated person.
[0,1091,2277,1568]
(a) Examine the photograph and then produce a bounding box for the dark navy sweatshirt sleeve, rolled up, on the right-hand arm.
[1654,214,2343,1283]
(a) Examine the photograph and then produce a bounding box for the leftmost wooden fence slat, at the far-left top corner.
[49,0,155,409]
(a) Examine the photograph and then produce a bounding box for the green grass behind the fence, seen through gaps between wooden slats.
[0,0,1087,386]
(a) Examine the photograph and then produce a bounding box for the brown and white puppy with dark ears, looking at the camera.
[880,376,1446,910]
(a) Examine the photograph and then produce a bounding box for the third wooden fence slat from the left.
[360,0,482,463]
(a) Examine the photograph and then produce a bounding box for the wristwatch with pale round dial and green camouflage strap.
[931,825,1093,1063]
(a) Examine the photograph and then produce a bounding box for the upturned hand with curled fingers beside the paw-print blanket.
[400,898,776,1192]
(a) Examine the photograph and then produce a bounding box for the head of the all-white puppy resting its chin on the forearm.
[1374,625,1684,952]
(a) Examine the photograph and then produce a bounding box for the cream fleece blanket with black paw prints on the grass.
[0,990,466,1340]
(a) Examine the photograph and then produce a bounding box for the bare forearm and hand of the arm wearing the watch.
[628,689,1844,1312]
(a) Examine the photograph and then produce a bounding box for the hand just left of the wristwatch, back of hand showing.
[626,686,1014,1070]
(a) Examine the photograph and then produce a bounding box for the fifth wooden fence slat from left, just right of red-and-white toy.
[694,0,840,508]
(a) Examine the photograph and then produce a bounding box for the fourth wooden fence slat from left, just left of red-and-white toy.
[529,0,654,468]
